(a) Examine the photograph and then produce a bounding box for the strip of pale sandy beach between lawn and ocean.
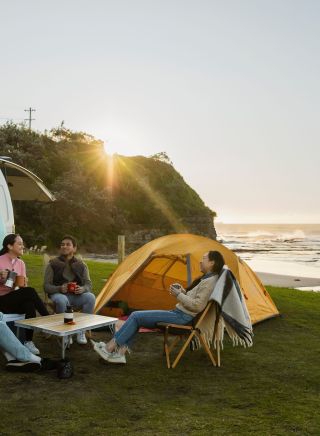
[256,271,320,290]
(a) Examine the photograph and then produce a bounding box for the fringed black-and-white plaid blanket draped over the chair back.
[192,267,253,348]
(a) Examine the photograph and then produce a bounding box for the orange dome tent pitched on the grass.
[95,234,279,324]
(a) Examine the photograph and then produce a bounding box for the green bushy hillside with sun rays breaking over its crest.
[0,123,215,252]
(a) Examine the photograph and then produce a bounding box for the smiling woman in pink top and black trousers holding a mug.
[0,234,49,354]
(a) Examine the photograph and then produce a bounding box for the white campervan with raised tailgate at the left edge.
[0,157,55,243]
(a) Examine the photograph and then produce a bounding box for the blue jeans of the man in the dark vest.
[49,292,96,313]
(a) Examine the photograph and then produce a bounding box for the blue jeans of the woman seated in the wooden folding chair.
[114,309,193,348]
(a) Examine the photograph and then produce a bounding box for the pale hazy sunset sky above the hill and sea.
[0,0,320,223]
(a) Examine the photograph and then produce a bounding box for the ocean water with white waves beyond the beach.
[215,223,320,278]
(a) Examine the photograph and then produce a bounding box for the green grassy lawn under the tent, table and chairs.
[0,255,320,436]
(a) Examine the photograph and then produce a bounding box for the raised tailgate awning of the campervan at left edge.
[0,158,55,202]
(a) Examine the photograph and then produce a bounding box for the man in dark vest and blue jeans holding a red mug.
[44,236,95,344]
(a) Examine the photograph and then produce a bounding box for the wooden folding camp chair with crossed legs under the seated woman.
[157,301,220,368]
